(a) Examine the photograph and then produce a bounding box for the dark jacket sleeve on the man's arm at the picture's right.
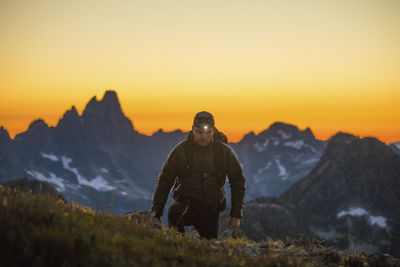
[227,147,246,218]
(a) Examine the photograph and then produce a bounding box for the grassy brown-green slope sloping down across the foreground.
[0,187,398,266]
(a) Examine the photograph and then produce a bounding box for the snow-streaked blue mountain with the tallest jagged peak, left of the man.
[0,91,186,212]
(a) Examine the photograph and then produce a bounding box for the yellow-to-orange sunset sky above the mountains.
[0,0,400,142]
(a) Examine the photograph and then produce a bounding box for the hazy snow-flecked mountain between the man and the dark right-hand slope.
[232,122,326,200]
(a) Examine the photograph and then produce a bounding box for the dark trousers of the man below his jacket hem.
[168,200,219,239]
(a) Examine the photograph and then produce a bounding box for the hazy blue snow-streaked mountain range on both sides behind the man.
[0,91,398,217]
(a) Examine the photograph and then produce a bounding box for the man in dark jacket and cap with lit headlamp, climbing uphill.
[151,111,246,239]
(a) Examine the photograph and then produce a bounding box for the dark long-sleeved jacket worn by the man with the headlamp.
[151,132,246,218]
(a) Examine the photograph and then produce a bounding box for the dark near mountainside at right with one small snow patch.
[238,133,400,255]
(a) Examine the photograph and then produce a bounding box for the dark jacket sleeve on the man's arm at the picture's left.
[151,147,177,217]
